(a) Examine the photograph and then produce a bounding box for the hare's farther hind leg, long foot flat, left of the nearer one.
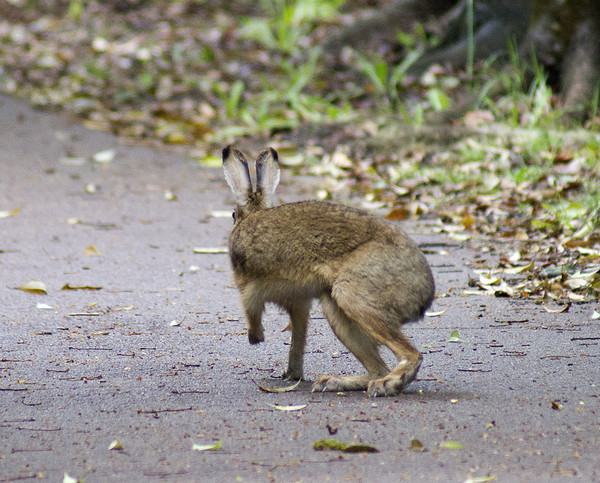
[312,295,389,391]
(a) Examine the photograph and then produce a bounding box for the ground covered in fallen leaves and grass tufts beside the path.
[0,0,600,302]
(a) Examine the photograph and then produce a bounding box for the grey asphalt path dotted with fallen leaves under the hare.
[0,97,600,482]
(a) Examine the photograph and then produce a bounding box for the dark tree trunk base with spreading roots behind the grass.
[325,0,600,119]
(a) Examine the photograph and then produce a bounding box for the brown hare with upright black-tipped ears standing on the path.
[223,146,435,397]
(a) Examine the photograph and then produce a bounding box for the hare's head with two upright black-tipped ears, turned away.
[223,146,279,223]
